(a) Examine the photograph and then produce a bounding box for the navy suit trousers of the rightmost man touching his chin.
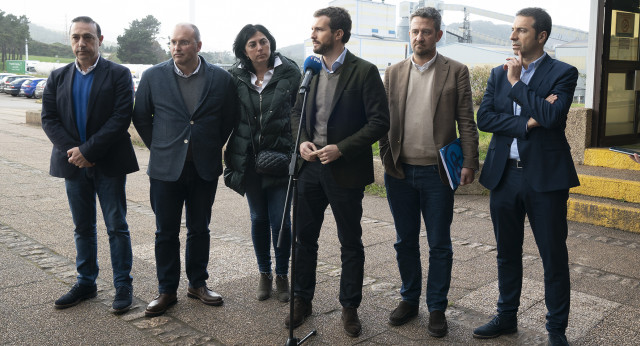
[490,167,571,334]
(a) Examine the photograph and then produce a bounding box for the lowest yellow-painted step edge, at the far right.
[567,198,640,233]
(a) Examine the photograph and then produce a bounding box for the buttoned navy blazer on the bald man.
[133,57,237,181]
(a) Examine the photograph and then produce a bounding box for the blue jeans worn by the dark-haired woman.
[245,167,291,275]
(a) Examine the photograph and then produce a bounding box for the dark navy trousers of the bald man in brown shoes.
[149,162,218,294]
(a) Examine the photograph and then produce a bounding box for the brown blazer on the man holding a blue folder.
[380,54,479,186]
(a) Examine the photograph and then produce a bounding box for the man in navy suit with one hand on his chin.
[473,8,579,345]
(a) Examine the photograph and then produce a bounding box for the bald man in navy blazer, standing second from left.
[133,23,237,317]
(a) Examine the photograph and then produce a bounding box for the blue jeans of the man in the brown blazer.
[384,164,453,312]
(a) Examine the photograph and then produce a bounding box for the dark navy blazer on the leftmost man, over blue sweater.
[42,58,138,178]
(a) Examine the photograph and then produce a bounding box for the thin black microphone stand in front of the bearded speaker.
[278,82,317,346]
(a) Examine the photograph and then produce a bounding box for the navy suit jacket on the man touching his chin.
[478,55,580,192]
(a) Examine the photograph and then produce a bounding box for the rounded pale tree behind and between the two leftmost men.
[116,15,167,64]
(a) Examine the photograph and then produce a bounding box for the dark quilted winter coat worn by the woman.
[224,53,301,195]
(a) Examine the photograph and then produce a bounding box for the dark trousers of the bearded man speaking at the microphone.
[294,161,364,308]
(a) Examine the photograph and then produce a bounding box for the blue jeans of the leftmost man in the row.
[65,168,133,287]
